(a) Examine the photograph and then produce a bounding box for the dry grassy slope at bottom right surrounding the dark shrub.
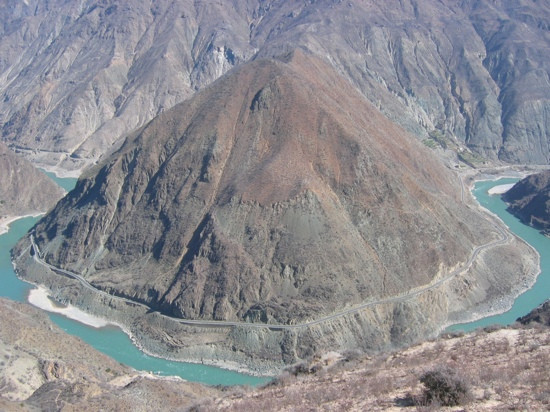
[196,328,550,411]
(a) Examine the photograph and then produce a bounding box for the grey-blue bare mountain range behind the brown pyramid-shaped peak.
[0,0,550,169]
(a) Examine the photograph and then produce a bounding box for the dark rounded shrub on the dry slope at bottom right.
[420,367,470,406]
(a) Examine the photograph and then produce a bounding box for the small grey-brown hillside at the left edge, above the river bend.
[0,142,63,222]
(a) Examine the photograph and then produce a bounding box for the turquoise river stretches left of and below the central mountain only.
[0,173,270,386]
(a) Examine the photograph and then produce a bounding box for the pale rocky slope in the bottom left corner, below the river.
[0,299,219,411]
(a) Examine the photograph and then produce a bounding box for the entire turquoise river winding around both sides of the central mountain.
[0,175,550,385]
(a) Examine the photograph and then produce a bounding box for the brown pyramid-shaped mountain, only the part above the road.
[29,52,475,323]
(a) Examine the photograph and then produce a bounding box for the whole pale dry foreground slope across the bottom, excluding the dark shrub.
[0,299,550,412]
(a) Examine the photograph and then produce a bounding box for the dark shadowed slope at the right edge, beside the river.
[502,170,550,236]
